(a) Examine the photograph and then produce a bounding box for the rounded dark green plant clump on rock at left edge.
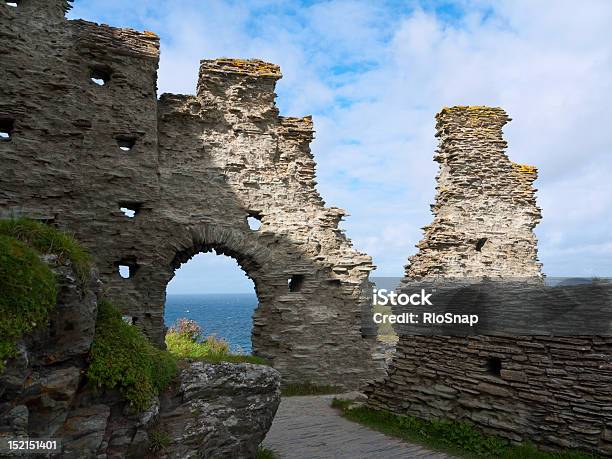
[0,235,57,371]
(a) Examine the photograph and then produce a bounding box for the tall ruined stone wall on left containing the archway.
[0,0,377,387]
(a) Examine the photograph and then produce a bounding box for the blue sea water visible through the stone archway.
[164,293,257,353]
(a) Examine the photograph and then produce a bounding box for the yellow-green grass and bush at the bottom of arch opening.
[166,319,269,365]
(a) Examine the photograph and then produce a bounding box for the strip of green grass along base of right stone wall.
[332,399,598,459]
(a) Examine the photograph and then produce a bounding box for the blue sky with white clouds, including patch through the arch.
[69,0,612,293]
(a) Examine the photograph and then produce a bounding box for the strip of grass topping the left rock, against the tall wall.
[0,218,92,283]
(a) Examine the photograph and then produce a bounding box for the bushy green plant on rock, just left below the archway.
[87,300,177,411]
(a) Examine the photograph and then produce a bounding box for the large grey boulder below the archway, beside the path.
[158,362,280,458]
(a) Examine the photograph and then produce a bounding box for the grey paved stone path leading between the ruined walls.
[263,395,450,459]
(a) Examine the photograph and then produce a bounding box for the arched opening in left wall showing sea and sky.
[164,250,259,354]
